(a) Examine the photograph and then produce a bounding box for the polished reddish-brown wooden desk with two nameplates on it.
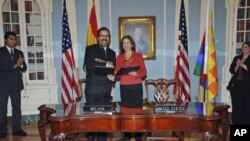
[38,103,229,141]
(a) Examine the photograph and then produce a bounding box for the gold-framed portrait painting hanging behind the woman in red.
[119,16,156,60]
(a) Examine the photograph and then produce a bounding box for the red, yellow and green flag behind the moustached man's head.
[83,0,98,72]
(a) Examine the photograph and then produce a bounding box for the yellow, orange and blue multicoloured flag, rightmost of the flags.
[194,0,218,102]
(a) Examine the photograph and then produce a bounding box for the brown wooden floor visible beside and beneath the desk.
[0,122,229,141]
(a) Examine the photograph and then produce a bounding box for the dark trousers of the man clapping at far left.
[0,86,21,133]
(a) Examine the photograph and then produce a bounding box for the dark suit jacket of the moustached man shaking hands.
[84,44,116,94]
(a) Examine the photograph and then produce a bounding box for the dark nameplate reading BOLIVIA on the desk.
[83,105,112,115]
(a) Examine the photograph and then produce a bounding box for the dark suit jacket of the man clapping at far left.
[0,46,27,91]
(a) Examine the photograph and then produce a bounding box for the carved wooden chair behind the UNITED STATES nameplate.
[144,78,184,141]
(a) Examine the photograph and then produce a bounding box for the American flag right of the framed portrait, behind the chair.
[174,0,191,102]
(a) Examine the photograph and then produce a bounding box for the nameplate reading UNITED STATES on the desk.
[155,104,186,113]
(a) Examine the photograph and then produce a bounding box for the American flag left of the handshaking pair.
[62,0,79,104]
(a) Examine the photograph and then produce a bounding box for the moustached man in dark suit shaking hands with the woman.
[84,27,116,141]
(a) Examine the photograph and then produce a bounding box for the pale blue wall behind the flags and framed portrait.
[52,0,226,101]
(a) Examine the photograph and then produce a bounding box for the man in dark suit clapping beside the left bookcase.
[0,32,27,138]
